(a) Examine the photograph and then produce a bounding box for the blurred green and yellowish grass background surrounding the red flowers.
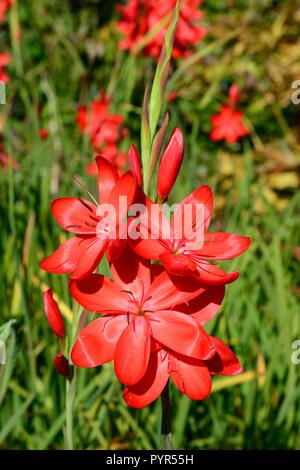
[0,0,300,449]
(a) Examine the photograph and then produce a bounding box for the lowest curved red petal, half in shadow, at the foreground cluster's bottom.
[123,350,169,408]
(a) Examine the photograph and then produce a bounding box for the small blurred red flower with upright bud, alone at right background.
[210,84,249,144]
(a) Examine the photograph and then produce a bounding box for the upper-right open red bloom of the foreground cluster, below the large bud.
[129,186,250,286]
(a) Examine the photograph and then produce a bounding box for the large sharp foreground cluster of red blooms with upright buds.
[41,129,250,408]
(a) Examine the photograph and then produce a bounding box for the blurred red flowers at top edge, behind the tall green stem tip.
[118,0,206,57]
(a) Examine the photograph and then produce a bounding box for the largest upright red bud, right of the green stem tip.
[157,127,184,202]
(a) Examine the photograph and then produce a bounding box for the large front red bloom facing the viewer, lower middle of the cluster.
[70,249,224,385]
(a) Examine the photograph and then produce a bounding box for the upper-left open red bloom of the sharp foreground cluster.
[40,157,137,279]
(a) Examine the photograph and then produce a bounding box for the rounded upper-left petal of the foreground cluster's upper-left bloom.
[51,197,98,235]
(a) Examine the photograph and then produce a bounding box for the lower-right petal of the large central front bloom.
[147,311,214,359]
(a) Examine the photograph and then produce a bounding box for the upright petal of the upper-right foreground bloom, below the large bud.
[171,186,213,237]
